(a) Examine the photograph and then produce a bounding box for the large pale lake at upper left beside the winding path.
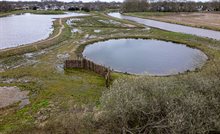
[0,13,85,49]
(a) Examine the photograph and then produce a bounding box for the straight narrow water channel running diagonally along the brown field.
[108,12,220,40]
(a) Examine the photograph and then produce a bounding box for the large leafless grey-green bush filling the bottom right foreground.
[94,75,220,134]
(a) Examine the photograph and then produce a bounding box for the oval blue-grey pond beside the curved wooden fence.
[83,39,208,76]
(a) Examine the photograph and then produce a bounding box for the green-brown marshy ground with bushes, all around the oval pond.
[0,9,220,134]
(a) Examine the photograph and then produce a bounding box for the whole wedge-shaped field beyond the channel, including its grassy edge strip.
[128,12,220,31]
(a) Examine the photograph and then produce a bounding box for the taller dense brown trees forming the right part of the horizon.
[121,0,220,12]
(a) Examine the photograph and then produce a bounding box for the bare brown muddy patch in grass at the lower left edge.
[0,87,29,109]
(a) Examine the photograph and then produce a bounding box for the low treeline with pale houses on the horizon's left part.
[0,1,122,11]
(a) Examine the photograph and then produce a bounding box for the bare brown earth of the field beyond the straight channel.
[148,13,220,30]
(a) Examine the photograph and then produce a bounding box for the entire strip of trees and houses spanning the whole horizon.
[0,0,220,12]
